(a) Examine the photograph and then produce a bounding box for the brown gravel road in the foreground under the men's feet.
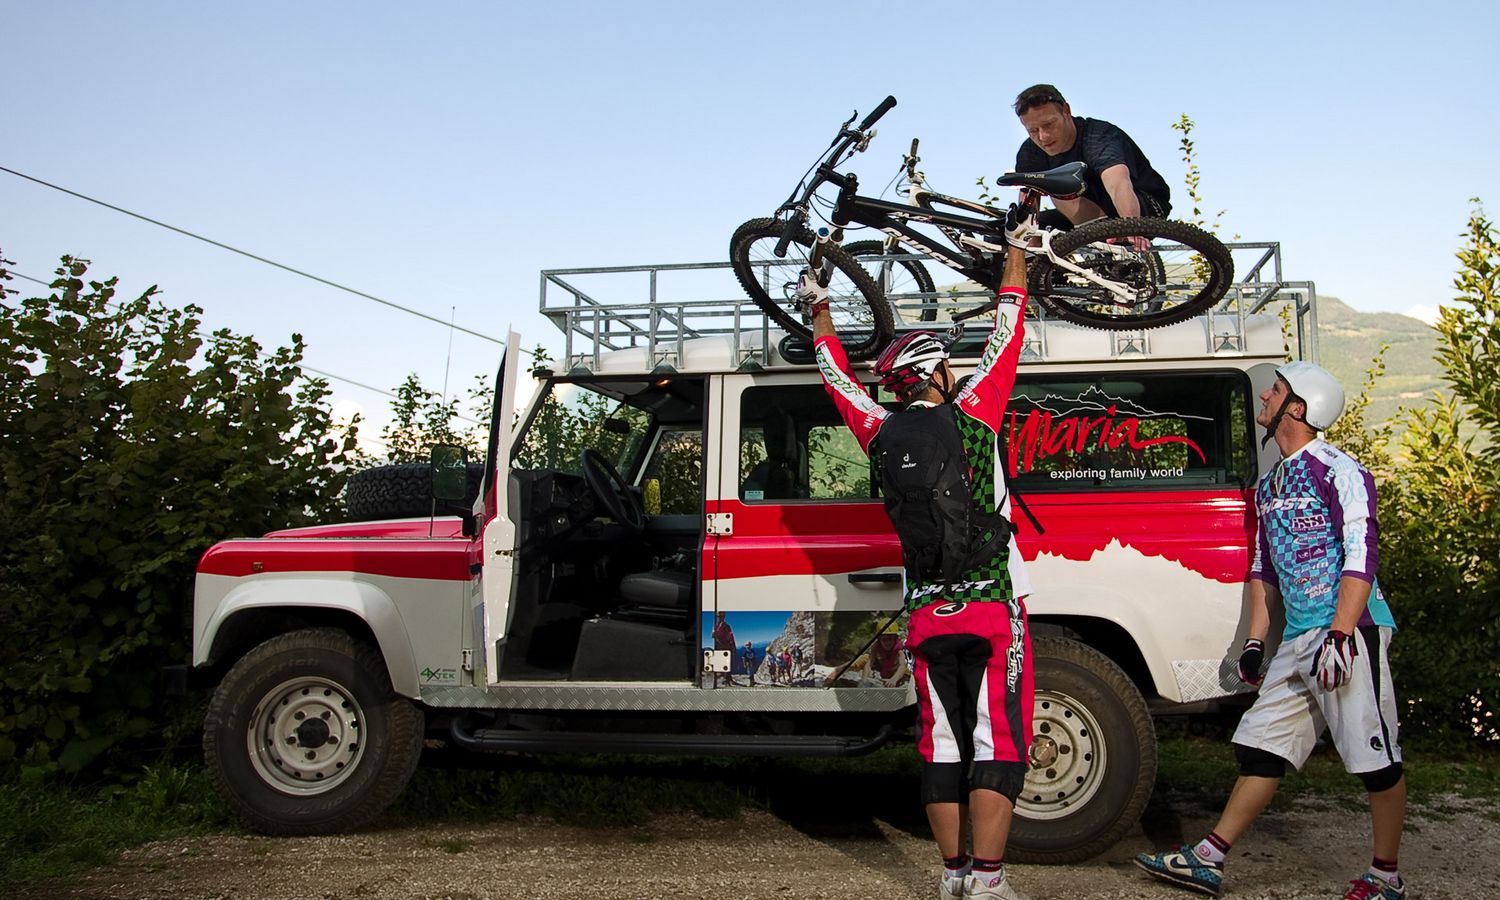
[29,797,1500,900]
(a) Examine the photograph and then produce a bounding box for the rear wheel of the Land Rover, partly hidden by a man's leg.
[1010,638,1157,864]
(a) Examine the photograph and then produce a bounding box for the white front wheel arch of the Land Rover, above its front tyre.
[194,579,422,699]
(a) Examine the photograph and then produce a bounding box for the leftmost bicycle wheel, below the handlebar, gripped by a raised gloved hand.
[729,219,896,360]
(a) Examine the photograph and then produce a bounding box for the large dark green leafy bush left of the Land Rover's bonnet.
[0,257,357,771]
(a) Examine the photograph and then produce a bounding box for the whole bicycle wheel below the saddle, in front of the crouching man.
[1032,219,1235,330]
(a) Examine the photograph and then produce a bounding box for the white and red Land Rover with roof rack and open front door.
[192,245,1316,863]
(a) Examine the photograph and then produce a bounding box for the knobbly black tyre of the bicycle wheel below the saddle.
[1028,218,1235,332]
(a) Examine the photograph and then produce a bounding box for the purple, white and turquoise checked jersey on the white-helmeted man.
[1250,438,1397,638]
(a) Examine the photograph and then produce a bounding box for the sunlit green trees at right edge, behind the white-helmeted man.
[1329,203,1500,744]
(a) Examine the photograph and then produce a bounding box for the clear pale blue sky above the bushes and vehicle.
[0,0,1500,444]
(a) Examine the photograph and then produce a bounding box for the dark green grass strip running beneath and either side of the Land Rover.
[0,735,1500,894]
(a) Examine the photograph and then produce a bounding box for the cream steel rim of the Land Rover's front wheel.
[245,677,365,797]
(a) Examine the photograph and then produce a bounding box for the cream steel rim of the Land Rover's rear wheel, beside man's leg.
[1016,690,1109,819]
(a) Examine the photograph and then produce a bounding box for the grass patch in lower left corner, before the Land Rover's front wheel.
[0,764,237,893]
